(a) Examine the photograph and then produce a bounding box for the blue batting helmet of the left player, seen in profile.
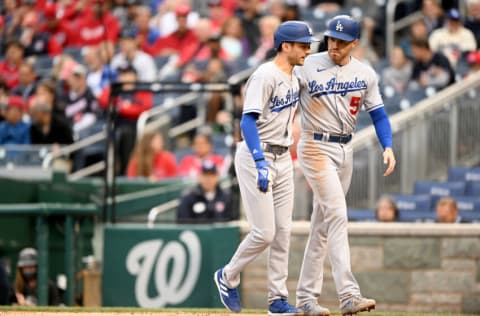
[273,21,318,50]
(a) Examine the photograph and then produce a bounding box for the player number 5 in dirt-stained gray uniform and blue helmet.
[295,15,395,316]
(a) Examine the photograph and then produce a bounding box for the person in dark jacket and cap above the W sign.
[177,160,238,223]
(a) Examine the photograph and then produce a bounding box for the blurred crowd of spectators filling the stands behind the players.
[0,0,480,215]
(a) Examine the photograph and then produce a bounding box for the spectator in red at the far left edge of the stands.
[0,40,25,89]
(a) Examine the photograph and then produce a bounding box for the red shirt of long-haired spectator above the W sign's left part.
[127,151,177,180]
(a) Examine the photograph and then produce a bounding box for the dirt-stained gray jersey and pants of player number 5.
[295,52,383,306]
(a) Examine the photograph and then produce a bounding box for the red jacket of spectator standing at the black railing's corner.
[98,87,153,121]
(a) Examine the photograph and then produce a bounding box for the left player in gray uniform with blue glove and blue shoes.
[214,21,315,316]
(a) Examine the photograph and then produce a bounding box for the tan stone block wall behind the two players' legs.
[241,222,480,313]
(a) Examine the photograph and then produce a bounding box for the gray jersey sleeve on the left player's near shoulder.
[243,71,274,114]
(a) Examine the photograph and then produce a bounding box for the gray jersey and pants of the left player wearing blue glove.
[223,62,299,303]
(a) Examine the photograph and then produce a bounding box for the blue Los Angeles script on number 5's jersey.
[308,77,368,97]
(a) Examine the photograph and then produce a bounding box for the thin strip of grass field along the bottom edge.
[0,306,474,316]
